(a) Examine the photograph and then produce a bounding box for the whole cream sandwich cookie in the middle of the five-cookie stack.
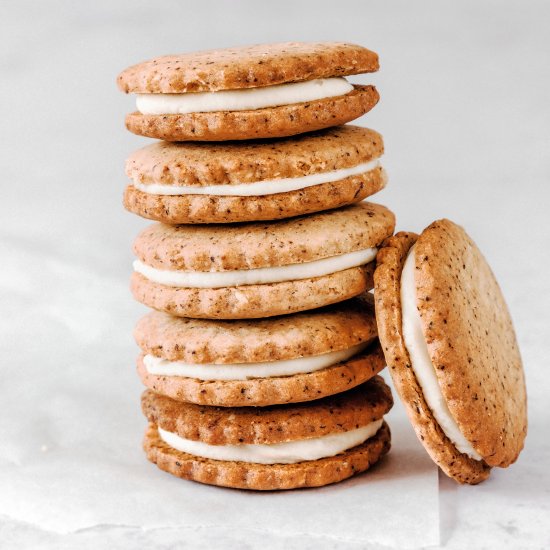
[131,202,395,319]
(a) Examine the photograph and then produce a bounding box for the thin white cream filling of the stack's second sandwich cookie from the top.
[133,159,380,197]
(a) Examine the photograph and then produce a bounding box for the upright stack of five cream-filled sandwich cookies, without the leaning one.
[118,43,395,490]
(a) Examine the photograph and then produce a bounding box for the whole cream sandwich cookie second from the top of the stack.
[124,126,386,224]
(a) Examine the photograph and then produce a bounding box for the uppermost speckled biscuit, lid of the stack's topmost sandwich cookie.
[117,42,378,94]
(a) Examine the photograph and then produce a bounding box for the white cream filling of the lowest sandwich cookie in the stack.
[158,419,383,464]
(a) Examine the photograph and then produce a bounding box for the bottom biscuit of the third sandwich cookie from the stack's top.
[130,262,374,319]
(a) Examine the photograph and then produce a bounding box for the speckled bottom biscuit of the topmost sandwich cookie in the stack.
[126,85,380,141]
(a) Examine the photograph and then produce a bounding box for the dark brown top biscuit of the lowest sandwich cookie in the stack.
[141,376,393,445]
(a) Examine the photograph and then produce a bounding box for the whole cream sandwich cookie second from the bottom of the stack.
[134,295,386,407]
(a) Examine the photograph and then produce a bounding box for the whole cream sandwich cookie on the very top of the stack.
[117,42,379,141]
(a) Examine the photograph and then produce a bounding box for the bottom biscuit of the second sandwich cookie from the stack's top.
[123,167,387,224]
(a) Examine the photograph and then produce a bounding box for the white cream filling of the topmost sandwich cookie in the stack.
[136,77,353,115]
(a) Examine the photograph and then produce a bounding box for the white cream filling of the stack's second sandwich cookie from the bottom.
[143,342,374,380]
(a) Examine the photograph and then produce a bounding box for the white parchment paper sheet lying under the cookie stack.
[0,239,439,548]
